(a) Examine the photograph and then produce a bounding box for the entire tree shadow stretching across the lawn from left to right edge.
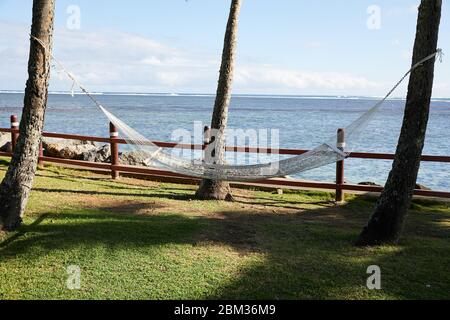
[0,195,450,299]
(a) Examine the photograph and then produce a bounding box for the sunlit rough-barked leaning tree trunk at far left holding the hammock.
[0,0,55,230]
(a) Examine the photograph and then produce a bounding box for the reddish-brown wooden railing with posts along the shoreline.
[0,116,450,202]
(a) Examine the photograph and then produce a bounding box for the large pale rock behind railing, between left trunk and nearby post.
[42,139,97,160]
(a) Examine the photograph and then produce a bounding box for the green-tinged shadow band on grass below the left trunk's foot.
[0,209,204,260]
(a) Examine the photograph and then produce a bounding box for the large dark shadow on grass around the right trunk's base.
[203,208,450,299]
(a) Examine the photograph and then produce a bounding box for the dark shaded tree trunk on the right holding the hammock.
[357,0,442,246]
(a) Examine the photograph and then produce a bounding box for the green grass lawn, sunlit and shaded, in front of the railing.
[0,160,450,299]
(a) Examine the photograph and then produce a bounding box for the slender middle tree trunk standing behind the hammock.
[196,0,241,200]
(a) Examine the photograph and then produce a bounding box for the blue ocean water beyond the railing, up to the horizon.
[0,93,450,191]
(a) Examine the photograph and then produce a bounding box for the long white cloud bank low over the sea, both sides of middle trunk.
[0,21,386,94]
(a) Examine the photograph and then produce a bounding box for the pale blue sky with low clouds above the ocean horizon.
[0,0,450,97]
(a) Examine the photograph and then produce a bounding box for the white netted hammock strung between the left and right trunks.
[31,36,442,181]
